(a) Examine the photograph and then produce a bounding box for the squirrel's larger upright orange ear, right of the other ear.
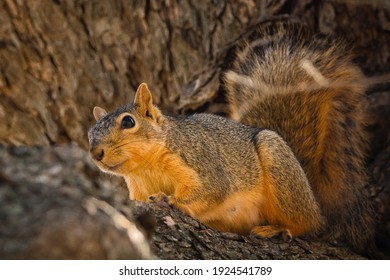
[134,83,159,120]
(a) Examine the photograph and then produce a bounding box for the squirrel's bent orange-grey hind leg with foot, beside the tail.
[251,130,323,238]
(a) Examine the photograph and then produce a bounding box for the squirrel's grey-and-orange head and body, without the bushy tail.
[89,84,322,245]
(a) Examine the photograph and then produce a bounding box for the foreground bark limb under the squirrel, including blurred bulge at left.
[0,146,361,259]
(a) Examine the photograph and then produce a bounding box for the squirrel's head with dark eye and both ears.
[88,83,165,175]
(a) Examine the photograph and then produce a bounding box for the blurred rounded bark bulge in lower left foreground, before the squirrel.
[0,147,152,259]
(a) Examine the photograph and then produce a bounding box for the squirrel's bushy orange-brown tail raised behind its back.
[224,21,374,252]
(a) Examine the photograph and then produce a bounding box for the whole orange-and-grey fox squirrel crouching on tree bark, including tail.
[88,20,374,255]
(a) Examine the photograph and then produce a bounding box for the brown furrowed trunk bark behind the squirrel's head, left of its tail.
[0,0,282,146]
